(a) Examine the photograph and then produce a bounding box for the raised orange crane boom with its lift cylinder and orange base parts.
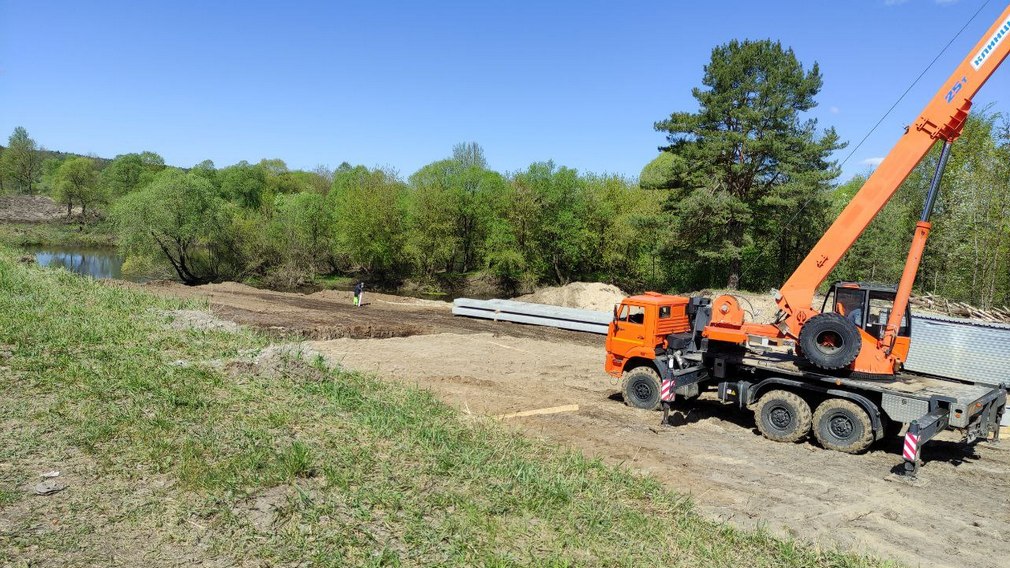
[706,5,1010,375]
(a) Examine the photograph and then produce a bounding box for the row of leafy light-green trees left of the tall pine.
[0,127,660,291]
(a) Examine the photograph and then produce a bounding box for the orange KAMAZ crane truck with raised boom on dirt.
[605,6,1010,475]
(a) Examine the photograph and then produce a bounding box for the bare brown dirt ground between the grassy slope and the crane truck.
[140,284,1010,567]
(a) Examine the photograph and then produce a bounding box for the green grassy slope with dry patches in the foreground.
[0,249,896,567]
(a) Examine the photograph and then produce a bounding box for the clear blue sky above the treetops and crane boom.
[0,0,1010,177]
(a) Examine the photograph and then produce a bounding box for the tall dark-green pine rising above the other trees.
[648,40,842,288]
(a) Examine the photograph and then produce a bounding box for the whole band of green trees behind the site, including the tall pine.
[0,40,1010,306]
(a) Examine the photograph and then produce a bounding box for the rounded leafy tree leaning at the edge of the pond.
[113,169,229,285]
